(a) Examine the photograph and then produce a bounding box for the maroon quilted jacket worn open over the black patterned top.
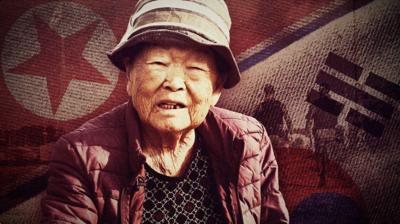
[42,101,288,224]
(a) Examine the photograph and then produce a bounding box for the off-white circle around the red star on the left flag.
[1,1,119,121]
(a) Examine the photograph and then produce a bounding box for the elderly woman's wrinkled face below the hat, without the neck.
[127,45,221,133]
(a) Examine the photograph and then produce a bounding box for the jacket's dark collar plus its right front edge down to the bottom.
[125,100,244,223]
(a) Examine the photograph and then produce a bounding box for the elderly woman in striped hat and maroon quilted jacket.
[42,0,288,223]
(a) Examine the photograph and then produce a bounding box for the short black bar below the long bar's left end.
[307,89,344,116]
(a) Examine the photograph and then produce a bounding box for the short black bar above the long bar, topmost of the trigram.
[325,52,363,80]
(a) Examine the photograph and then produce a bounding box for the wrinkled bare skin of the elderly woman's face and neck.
[127,45,223,176]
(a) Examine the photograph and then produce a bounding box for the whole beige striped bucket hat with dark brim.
[107,0,240,88]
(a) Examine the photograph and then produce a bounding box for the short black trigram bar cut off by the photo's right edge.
[365,72,400,100]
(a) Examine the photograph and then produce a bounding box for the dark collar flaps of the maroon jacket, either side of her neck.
[125,100,243,180]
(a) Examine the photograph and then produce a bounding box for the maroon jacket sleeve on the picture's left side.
[41,138,97,223]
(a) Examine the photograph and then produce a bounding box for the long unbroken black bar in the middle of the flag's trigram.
[316,71,394,119]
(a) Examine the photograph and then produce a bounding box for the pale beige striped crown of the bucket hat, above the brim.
[127,0,232,45]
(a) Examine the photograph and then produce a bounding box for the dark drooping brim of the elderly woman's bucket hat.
[107,28,240,89]
